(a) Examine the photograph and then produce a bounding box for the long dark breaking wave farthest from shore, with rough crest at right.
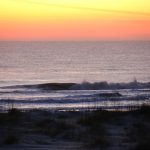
[1,80,150,90]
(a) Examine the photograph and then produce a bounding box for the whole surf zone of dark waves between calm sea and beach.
[0,81,150,109]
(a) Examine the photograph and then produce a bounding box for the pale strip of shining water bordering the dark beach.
[3,100,150,110]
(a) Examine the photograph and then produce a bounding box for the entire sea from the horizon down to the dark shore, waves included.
[0,41,150,110]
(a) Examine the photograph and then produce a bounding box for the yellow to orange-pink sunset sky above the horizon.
[0,0,150,40]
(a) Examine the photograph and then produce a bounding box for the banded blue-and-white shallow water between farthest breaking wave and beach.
[0,89,150,110]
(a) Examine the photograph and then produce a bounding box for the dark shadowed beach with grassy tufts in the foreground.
[0,106,150,150]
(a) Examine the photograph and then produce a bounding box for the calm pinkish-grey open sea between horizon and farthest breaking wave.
[0,41,150,85]
